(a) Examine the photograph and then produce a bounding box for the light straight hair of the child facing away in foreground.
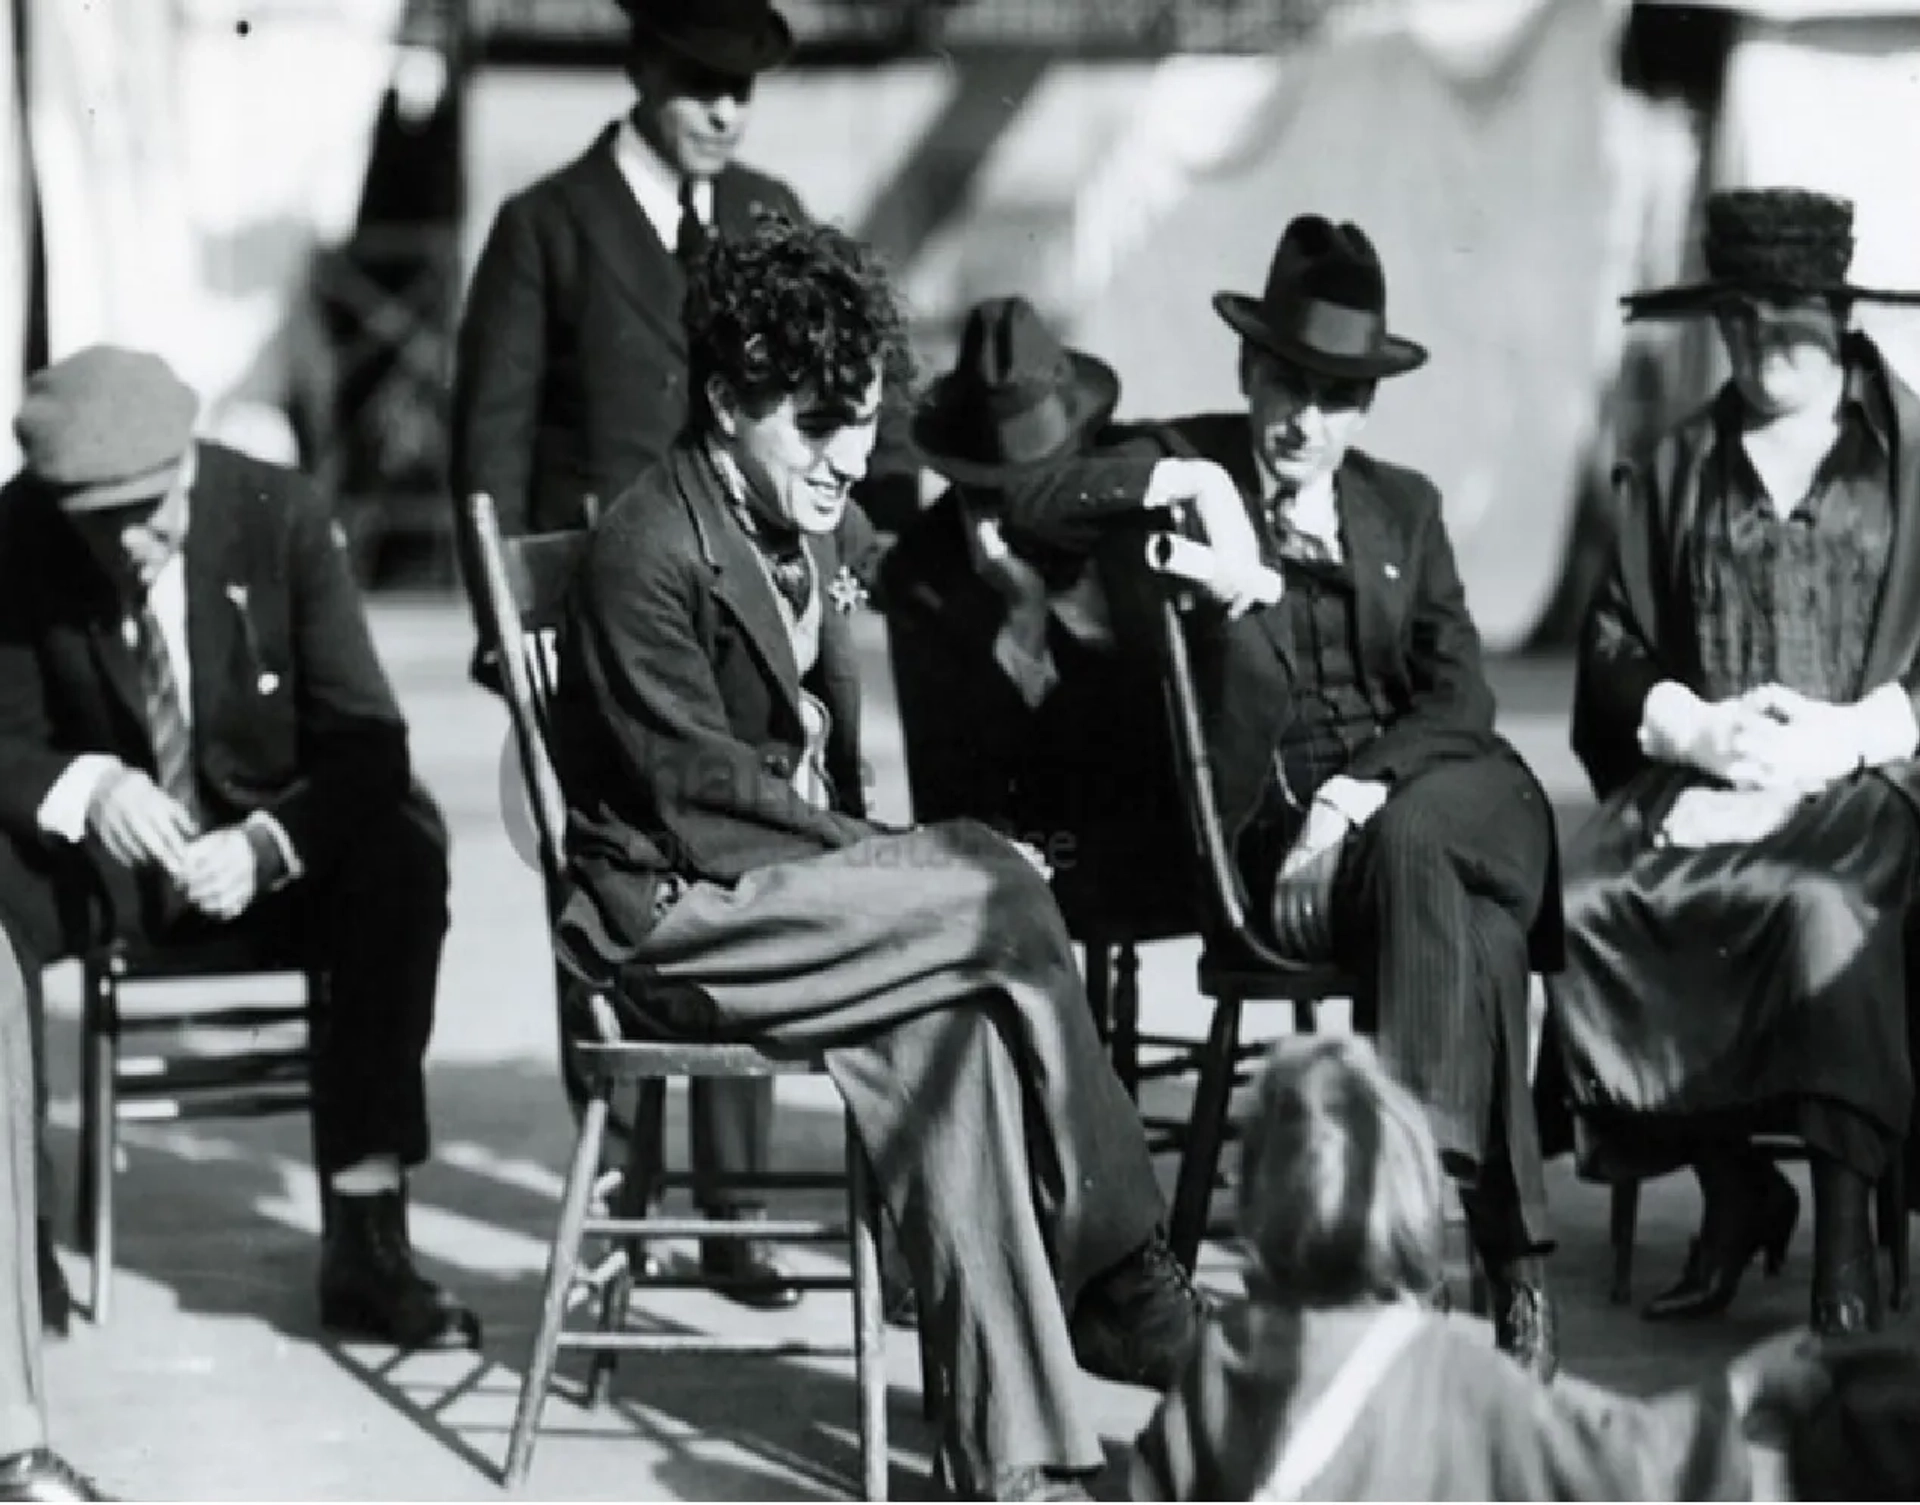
[1240,1035,1444,1307]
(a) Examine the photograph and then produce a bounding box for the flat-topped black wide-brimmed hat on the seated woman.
[1620,188,1920,319]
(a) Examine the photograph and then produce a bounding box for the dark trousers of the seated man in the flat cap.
[0,789,447,1173]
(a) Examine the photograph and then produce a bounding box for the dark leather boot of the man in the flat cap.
[321,1192,480,1348]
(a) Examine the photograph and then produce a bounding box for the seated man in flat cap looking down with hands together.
[0,346,480,1348]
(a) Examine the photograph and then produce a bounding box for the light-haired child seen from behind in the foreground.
[1131,1037,1826,1499]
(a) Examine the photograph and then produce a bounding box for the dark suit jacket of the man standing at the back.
[451,127,806,538]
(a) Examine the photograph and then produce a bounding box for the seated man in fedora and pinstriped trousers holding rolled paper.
[1010,215,1563,1374]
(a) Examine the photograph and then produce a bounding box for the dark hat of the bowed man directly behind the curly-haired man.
[910,298,1119,486]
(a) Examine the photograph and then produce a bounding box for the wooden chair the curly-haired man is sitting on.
[463,495,887,1499]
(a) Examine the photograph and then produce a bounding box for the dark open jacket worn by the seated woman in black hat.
[1572,334,1920,804]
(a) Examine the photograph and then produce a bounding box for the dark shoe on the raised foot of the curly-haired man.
[1068,1234,1208,1390]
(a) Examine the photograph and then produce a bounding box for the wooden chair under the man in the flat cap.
[77,931,326,1325]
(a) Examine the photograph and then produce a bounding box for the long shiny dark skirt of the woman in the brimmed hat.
[1549,766,1920,1179]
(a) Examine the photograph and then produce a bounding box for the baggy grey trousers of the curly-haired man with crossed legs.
[563,822,1164,1493]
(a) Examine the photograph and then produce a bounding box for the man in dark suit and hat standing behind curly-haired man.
[451,0,825,1305]
